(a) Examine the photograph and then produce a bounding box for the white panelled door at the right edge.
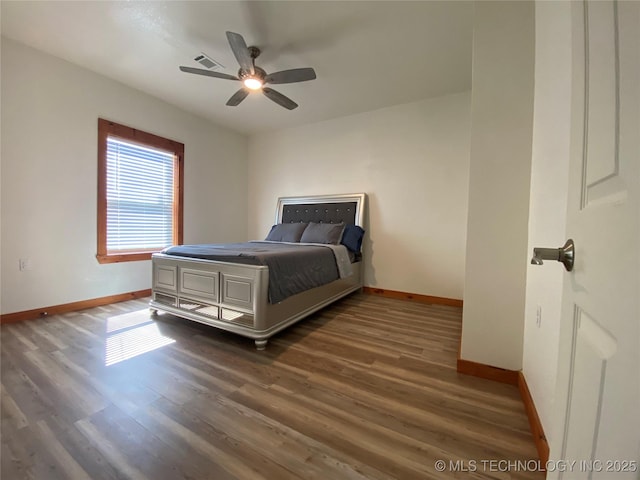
[548,1,640,480]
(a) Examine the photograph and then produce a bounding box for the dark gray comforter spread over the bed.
[162,242,346,303]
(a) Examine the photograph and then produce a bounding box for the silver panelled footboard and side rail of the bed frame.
[150,254,362,348]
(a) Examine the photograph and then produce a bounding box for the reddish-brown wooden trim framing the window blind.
[96,118,184,263]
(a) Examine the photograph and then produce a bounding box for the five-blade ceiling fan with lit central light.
[180,32,316,110]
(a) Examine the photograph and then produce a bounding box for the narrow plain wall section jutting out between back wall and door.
[461,2,534,370]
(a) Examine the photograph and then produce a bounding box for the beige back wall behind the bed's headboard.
[249,92,469,299]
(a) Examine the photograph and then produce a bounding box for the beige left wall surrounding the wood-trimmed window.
[0,38,247,313]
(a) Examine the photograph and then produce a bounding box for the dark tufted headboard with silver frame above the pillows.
[276,193,366,228]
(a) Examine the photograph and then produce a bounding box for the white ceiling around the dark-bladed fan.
[0,0,473,133]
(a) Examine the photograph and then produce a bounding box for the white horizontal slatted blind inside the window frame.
[107,137,174,253]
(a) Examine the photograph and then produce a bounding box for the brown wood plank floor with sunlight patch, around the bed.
[1,294,544,480]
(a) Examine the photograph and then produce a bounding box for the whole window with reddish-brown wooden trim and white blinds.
[96,118,184,263]
